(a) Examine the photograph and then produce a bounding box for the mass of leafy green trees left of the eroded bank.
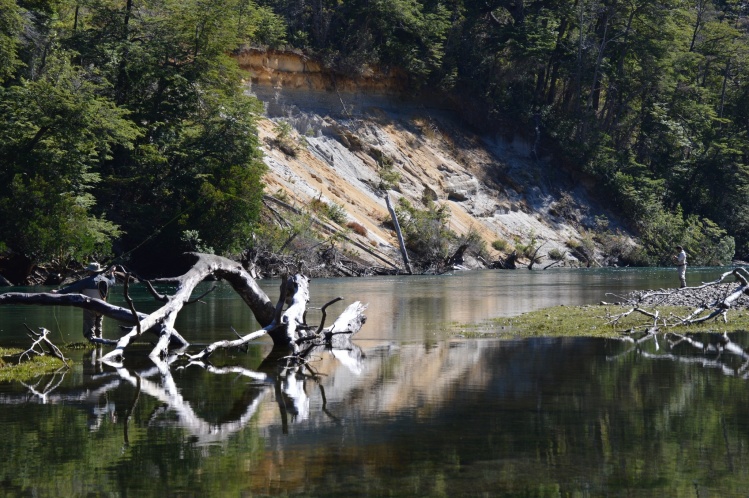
[0,0,268,272]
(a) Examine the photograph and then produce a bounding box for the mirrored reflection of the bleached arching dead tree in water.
[0,342,363,446]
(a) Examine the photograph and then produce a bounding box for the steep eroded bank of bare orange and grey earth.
[238,48,611,270]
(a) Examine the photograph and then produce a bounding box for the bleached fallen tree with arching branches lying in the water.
[0,253,366,362]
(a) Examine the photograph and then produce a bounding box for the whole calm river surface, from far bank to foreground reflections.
[0,268,749,497]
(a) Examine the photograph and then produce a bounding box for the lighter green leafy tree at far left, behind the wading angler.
[0,52,134,266]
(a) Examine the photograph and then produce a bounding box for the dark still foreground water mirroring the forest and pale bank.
[0,334,749,496]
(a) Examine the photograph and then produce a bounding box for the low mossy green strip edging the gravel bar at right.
[454,305,749,338]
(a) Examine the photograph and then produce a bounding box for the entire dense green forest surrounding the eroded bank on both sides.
[0,0,749,280]
